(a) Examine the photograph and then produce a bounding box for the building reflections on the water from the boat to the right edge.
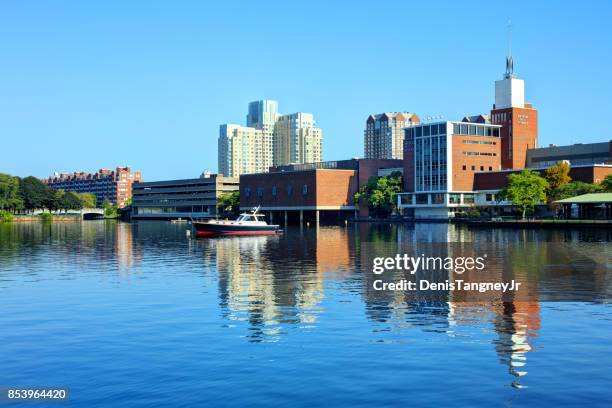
[199,224,609,388]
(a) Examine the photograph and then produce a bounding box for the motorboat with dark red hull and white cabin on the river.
[192,207,281,236]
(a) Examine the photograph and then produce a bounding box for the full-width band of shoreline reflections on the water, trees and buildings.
[0,221,612,388]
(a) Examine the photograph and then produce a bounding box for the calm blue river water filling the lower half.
[0,221,612,407]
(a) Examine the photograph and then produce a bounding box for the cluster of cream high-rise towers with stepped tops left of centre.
[218,100,322,177]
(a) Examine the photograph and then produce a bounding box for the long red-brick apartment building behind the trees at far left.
[43,167,142,208]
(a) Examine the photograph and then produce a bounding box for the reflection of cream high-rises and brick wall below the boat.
[210,228,354,341]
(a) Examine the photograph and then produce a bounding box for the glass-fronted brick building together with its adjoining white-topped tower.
[398,56,538,219]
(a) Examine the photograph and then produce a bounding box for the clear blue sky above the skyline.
[0,0,612,181]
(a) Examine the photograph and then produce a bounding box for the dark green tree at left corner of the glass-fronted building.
[354,172,402,217]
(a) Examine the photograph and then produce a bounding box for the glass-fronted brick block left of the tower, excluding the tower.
[399,121,501,218]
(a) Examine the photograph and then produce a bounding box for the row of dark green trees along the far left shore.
[0,173,96,214]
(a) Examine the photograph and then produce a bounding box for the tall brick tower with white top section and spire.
[491,52,538,169]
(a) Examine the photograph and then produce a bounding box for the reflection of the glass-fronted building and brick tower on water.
[357,224,553,388]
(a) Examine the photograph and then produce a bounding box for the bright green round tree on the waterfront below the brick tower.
[498,170,548,219]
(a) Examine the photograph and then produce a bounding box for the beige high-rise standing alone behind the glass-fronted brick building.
[363,112,420,159]
